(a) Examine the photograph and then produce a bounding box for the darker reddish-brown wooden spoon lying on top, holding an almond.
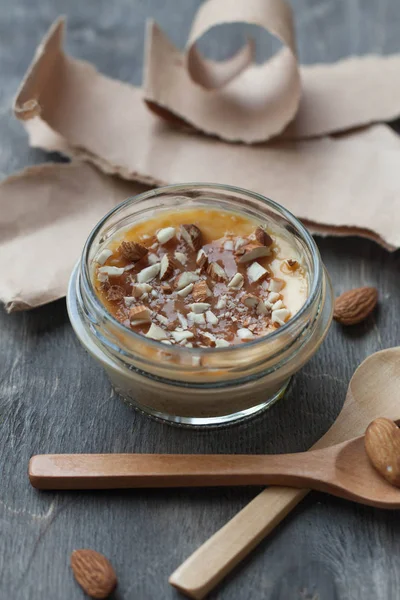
[29,421,400,509]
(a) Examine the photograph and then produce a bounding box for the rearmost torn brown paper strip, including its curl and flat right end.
[144,0,400,143]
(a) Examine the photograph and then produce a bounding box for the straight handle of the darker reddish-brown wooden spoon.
[29,454,312,490]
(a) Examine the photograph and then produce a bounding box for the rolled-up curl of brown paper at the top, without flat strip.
[144,0,301,143]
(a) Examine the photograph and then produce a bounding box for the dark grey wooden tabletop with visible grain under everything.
[0,0,400,600]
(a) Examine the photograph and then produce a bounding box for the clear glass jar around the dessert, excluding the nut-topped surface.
[67,183,333,426]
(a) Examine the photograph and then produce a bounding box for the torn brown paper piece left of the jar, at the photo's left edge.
[0,163,143,312]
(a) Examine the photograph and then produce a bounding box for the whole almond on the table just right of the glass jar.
[333,287,378,325]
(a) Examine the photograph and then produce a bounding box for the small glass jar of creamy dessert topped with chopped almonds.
[68,184,332,426]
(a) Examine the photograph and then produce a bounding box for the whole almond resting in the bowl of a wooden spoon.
[364,417,400,487]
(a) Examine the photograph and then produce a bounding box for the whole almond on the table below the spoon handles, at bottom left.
[71,549,117,599]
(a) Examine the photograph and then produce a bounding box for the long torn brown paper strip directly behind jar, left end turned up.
[11,17,400,248]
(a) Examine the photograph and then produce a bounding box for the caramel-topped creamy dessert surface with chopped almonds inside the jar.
[94,208,308,348]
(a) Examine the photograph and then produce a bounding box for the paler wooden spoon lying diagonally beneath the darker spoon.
[169,348,400,599]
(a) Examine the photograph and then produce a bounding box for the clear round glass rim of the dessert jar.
[80,182,323,356]
